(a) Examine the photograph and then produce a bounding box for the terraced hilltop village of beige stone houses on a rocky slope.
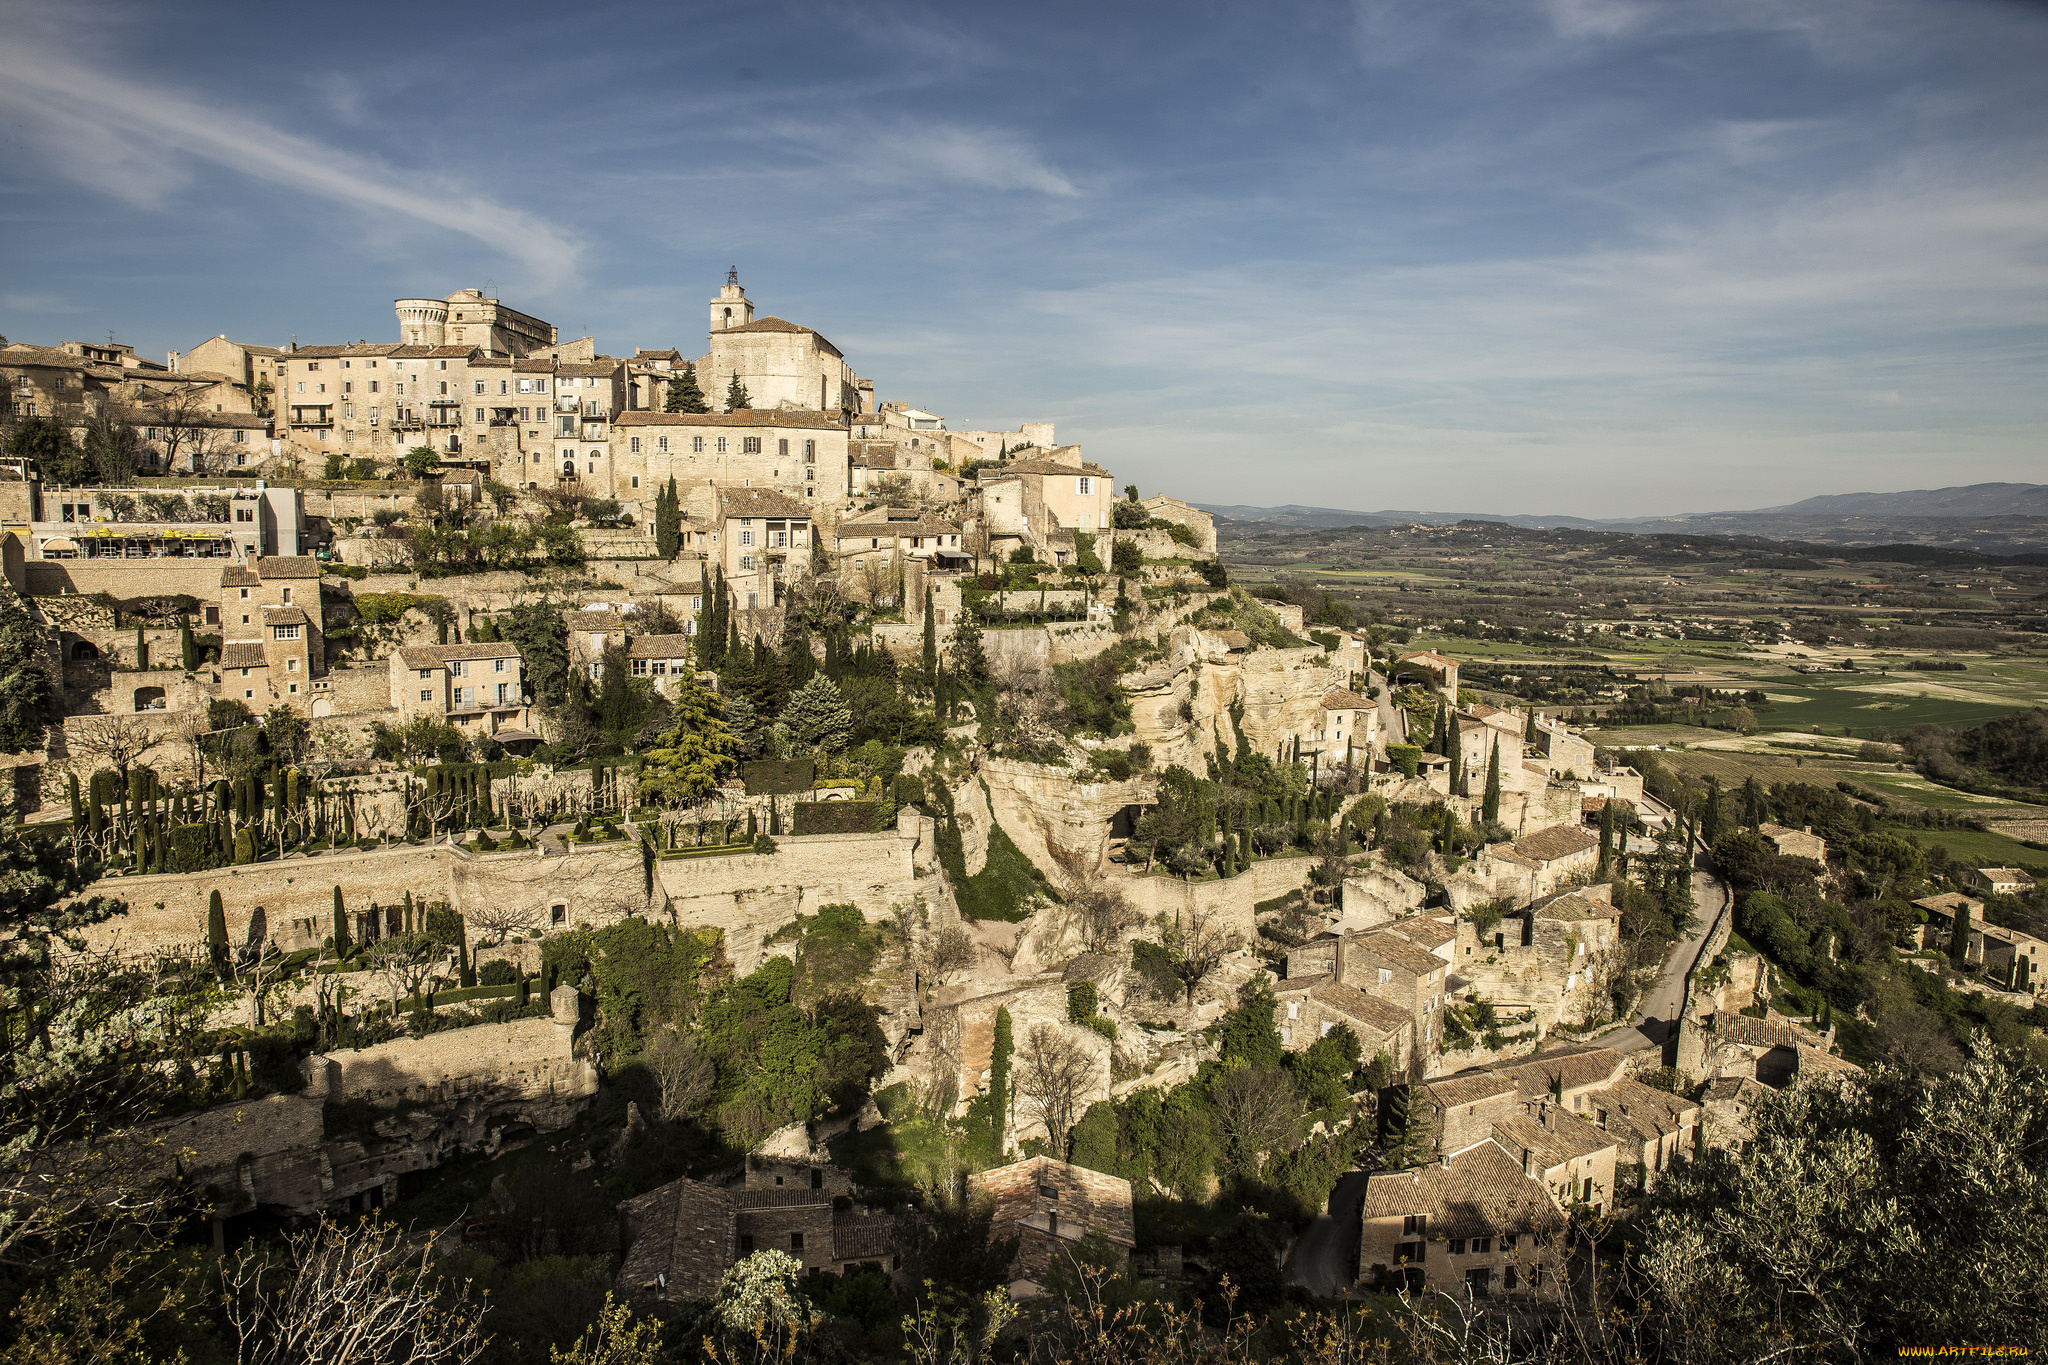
[0,276,1900,1350]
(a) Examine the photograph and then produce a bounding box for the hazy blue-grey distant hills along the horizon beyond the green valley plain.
[1198,483,2048,555]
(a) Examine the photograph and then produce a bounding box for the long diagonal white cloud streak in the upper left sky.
[0,6,582,291]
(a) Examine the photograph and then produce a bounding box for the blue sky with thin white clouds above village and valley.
[0,0,2048,516]
